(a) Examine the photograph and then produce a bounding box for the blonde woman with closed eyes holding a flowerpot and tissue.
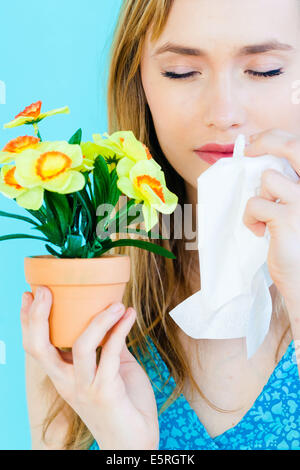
[21,0,300,450]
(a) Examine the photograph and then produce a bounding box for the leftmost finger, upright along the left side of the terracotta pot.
[27,287,72,384]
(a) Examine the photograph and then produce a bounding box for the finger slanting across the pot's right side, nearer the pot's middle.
[72,302,125,387]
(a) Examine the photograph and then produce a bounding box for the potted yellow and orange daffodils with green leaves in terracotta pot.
[0,101,178,348]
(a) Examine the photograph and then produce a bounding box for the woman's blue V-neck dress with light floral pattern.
[90,338,300,450]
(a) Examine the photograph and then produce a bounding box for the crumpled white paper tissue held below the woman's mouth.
[169,134,299,358]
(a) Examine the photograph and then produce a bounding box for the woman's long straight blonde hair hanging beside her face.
[43,0,287,450]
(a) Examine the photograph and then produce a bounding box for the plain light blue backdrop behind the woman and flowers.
[0,0,122,450]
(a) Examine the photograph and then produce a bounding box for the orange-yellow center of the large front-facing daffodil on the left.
[36,151,72,181]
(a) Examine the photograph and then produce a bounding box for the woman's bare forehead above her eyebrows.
[145,0,300,56]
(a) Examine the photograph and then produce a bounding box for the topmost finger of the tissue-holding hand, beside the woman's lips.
[245,129,300,175]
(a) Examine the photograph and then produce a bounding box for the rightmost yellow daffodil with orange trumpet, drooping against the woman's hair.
[117,159,178,232]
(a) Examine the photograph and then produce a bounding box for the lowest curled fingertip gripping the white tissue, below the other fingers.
[243,197,285,236]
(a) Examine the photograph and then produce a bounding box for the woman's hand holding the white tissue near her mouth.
[243,129,300,368]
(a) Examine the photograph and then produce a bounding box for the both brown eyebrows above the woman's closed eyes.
[152,40,295,57]
